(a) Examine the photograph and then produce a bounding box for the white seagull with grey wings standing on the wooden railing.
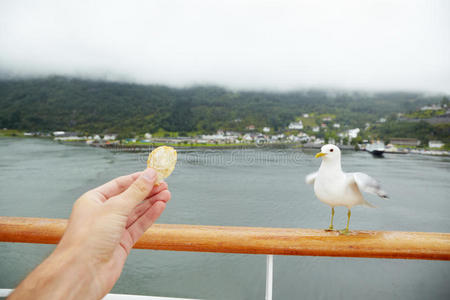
[305,144,388,234]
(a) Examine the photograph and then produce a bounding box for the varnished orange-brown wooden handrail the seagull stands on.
[0,217,450,260]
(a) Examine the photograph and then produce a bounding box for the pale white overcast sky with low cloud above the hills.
[0,0,450,93]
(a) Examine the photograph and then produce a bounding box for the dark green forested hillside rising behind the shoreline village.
[0,77,440,135]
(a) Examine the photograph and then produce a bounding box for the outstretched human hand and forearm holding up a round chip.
[10,168,170,299]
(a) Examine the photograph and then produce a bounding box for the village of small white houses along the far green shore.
[4,105,450,156]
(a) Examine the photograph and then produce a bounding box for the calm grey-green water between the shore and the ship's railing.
[0,139,450,300]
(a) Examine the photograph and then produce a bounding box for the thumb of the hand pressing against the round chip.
[109,168,157,214]
